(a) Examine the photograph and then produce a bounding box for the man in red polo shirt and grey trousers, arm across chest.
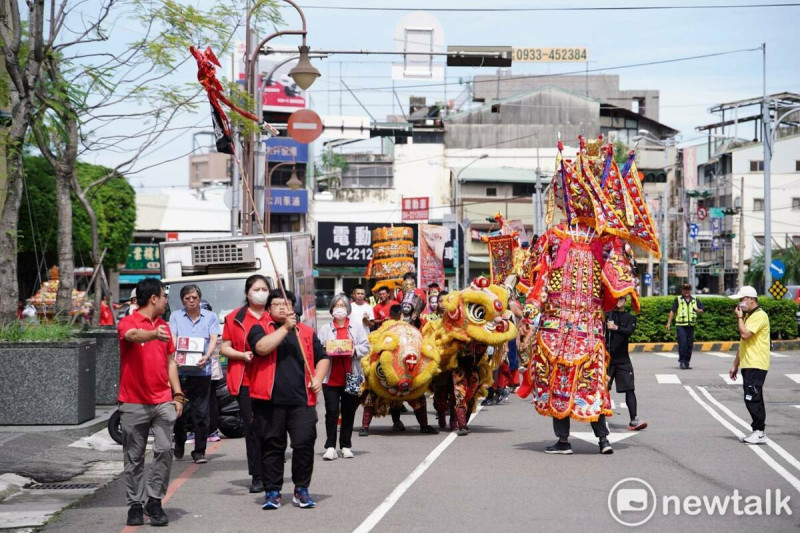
[117,278,186,526]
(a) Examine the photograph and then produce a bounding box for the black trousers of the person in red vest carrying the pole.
[253,400,317,491]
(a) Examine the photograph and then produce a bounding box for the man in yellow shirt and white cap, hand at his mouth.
[729,285,770,444]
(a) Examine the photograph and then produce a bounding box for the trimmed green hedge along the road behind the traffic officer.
[631,296,797,342]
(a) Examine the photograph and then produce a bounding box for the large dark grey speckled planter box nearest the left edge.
[0,339,95,425]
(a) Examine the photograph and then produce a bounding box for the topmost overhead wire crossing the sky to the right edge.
[303,2,800,13]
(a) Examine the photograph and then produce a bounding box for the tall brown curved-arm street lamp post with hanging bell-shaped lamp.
[242,0,320,235]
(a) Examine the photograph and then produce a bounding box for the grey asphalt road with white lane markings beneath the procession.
[40,352,800,533]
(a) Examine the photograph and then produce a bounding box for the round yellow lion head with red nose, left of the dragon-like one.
[361,320,440,400]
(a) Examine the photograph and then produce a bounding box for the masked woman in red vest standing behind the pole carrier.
[220,274,269,493]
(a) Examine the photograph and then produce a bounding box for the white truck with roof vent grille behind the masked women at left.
[160,233,316,328]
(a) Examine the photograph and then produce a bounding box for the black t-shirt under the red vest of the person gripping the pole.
[247,324,328,406]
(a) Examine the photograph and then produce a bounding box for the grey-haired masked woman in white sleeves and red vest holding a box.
[319,294,369,461]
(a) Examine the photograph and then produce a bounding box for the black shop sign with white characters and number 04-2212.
[316,222,464,268]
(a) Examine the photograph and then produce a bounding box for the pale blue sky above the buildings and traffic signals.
[79,0,800,193]
